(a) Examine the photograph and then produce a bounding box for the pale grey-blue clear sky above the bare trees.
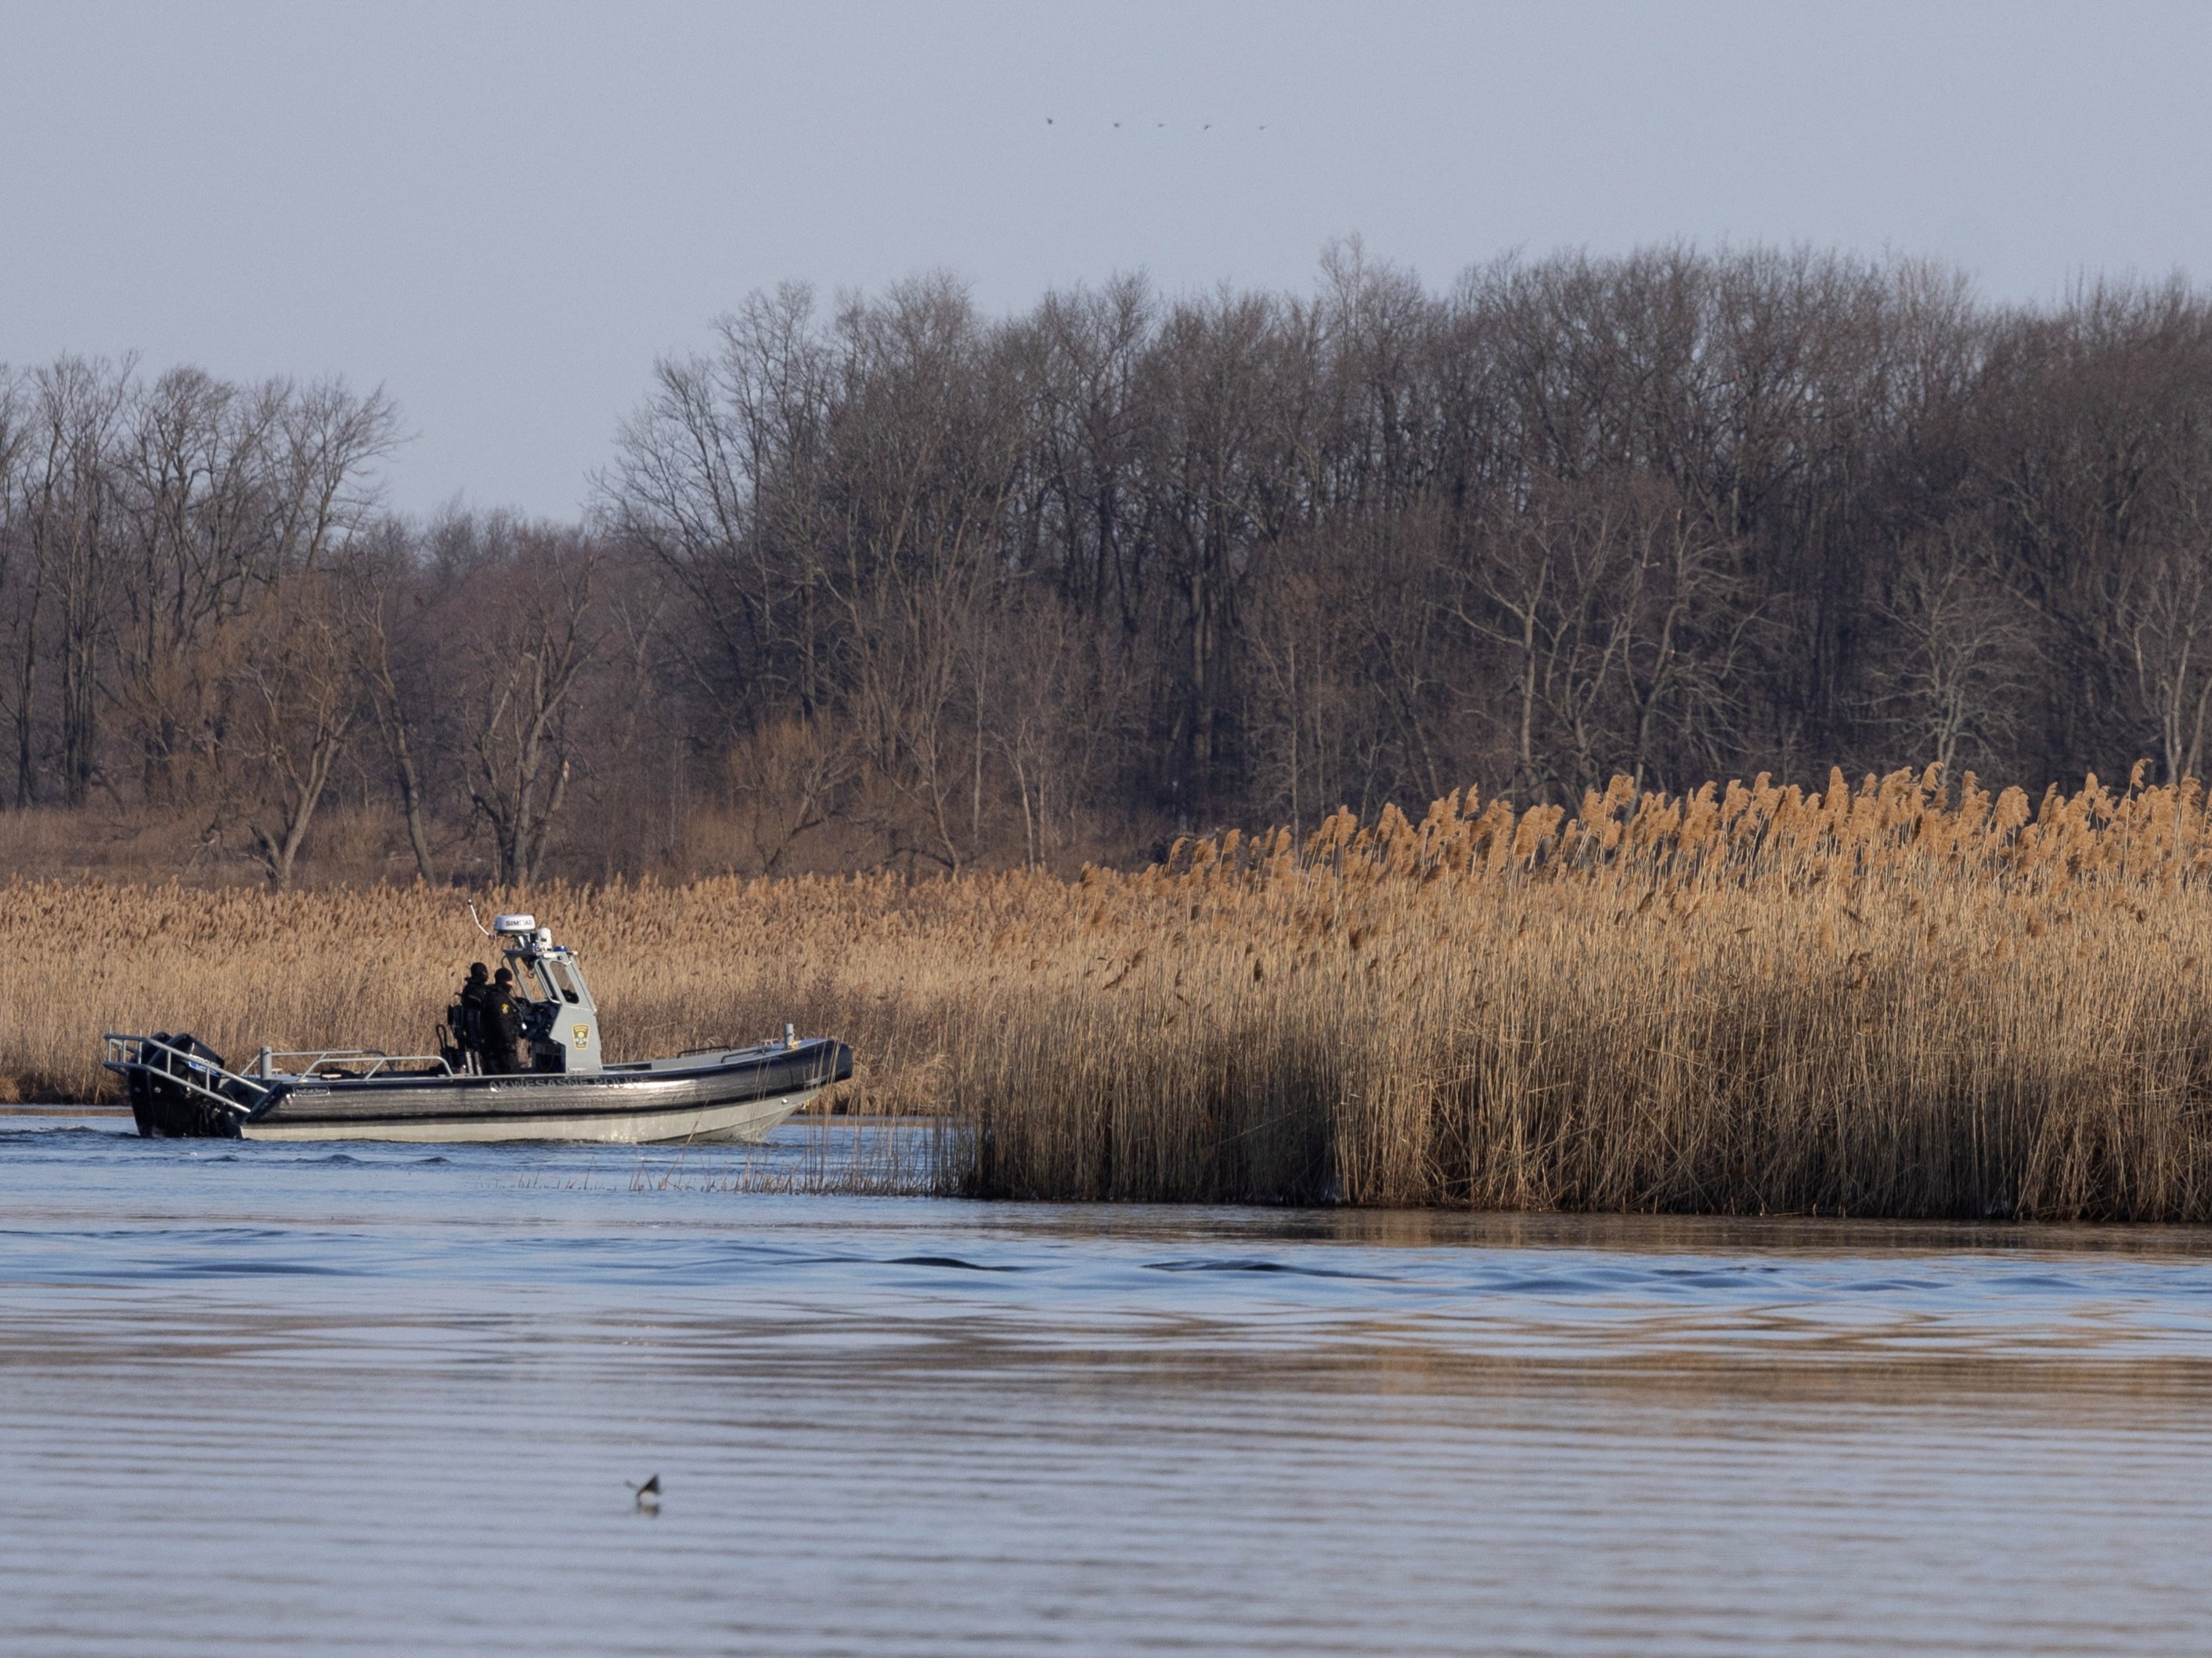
[0,0,2212,515]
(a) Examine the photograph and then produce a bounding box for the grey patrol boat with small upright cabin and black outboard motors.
[102,915,852,1145]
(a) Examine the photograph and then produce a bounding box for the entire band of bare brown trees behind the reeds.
[13,245,2212,882]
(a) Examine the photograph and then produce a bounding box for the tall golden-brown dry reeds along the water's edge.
[13,773,2212,1220]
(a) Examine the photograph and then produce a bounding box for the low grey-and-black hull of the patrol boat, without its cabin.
[131,1041,852,1145]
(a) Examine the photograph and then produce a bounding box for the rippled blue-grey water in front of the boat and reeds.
[0,1119,2212,1653]
